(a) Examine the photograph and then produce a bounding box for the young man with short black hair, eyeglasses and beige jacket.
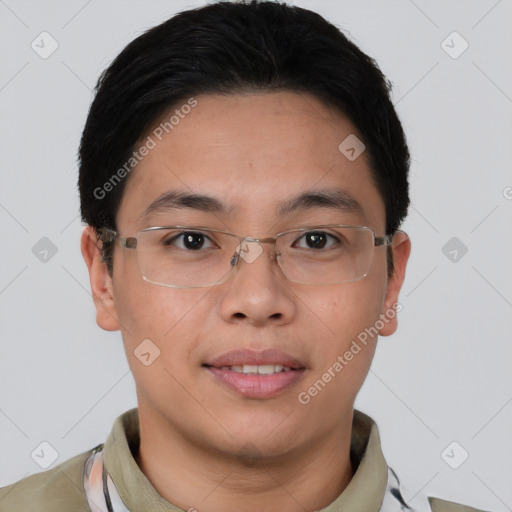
[0,2,488,512]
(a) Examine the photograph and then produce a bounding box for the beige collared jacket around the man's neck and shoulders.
[0,409,488,512]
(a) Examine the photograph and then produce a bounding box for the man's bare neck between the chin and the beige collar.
[135,407,353,512]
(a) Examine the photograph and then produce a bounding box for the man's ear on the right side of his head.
[379,231,411,336]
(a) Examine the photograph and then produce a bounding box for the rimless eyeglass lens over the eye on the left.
[137,228,238,288]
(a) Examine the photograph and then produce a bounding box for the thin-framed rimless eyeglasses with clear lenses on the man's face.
[101,224,393,288]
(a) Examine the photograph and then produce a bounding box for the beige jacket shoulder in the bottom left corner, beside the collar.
[0,450,92,512]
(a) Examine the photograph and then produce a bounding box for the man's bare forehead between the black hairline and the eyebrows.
[118,92,385,232]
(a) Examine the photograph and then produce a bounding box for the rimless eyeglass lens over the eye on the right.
[277,226,374,285]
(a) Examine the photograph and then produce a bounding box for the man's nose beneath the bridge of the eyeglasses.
[221,238,296,326]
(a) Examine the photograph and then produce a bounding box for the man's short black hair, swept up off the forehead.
[78,0,410,271]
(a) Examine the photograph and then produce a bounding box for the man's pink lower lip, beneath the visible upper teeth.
[207,367,304,398]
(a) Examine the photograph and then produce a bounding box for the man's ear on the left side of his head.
[81,226,119,331]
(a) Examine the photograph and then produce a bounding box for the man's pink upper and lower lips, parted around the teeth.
[203,349,306,399]
